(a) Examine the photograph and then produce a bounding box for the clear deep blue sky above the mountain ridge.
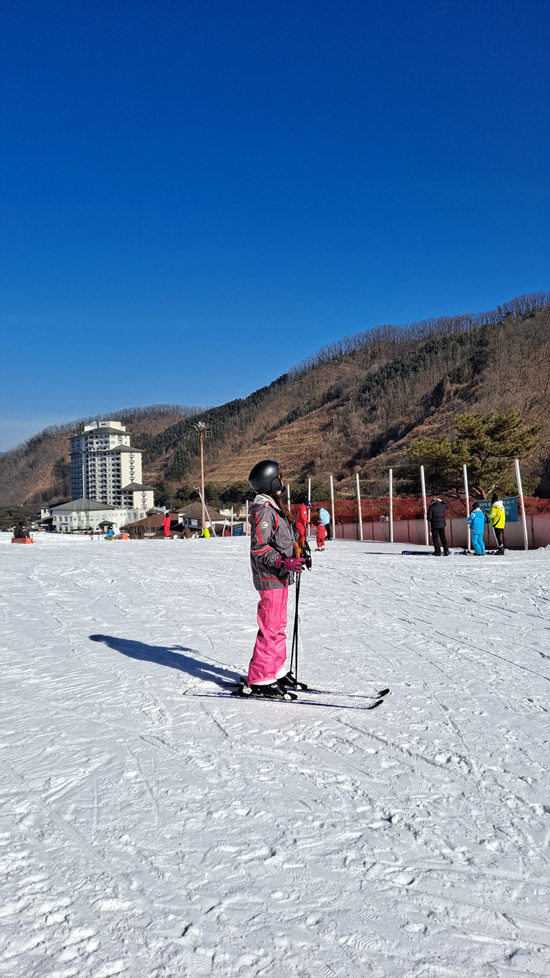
[0,0,550,450]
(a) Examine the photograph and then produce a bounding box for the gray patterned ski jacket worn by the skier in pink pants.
[248,494,297,591]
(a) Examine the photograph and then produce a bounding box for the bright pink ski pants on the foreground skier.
[248,587,288,685]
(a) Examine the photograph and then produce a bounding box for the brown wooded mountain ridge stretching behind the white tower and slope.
[0,293,550,506]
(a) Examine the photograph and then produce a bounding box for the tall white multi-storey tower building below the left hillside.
[71,421,154,510]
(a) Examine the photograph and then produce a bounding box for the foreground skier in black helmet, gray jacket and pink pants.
[247,459,304,699]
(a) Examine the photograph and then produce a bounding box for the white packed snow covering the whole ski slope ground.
[0,536,550,978]
